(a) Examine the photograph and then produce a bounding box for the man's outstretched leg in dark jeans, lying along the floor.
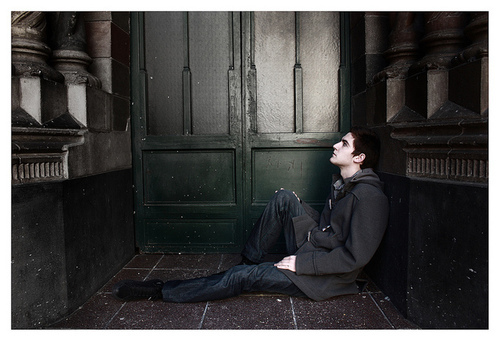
[162,263,305,302]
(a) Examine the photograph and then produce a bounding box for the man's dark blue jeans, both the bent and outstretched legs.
[162,190,306,302]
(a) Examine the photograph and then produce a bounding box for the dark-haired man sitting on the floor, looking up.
[113,127,389,302]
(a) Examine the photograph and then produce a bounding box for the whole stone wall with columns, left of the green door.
[11,12,135,328]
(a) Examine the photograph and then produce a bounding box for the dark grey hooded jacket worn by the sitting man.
[282,168,389,301]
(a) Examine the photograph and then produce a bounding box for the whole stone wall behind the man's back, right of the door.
[351,12,488,328]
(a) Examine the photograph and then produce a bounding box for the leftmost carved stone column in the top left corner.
[11,11,64,82]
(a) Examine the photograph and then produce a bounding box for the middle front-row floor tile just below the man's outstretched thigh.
[202,295,295,329]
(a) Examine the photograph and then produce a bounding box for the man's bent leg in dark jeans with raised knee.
[241,190,307,263]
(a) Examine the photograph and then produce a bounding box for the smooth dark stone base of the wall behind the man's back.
[365,173,488,329]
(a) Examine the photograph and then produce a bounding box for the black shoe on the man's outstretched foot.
[113,279,163,301]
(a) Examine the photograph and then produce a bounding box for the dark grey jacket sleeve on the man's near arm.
[296,190,389,275]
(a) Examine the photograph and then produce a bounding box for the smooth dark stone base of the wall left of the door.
[11,169,135,329]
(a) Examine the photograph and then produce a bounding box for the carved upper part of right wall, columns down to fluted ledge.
[367,12,488,182]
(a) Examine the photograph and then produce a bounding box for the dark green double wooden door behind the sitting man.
[131,12,349,253]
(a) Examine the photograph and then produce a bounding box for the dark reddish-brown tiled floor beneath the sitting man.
[48,254,418,329]
